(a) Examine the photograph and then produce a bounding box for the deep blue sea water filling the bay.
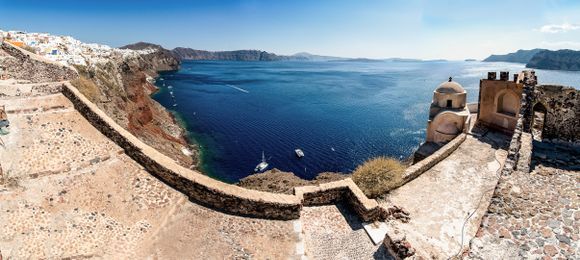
[154,61,580,182]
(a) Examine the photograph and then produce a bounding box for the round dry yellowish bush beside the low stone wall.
[352,156,405,198]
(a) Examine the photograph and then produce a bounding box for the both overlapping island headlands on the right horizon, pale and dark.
[483,49,580,71]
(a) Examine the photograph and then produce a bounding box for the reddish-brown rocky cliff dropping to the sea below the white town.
[72,47,197,167]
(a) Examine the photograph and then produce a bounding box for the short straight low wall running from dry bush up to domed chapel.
[400,133,467,189]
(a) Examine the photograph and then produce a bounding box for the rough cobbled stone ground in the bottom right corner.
[468,155,580,259]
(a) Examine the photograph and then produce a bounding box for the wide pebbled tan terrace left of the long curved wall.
[0,89,300,259]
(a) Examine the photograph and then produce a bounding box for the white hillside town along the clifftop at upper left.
[0,30,154,66]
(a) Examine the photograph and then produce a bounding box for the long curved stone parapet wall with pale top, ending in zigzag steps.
[62,82,395,221]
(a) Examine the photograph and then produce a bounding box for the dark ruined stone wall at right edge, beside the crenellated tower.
[528,85,580,142]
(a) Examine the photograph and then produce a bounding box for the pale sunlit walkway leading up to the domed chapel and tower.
[380,132,508,259]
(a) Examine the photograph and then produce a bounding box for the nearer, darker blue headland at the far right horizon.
[526,50,580,71]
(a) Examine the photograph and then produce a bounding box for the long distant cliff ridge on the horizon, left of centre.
[172,47,303,61]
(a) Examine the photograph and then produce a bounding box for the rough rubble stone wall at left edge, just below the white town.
[0,42,78,83]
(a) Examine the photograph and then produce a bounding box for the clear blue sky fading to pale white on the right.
[0,0,580,59]
